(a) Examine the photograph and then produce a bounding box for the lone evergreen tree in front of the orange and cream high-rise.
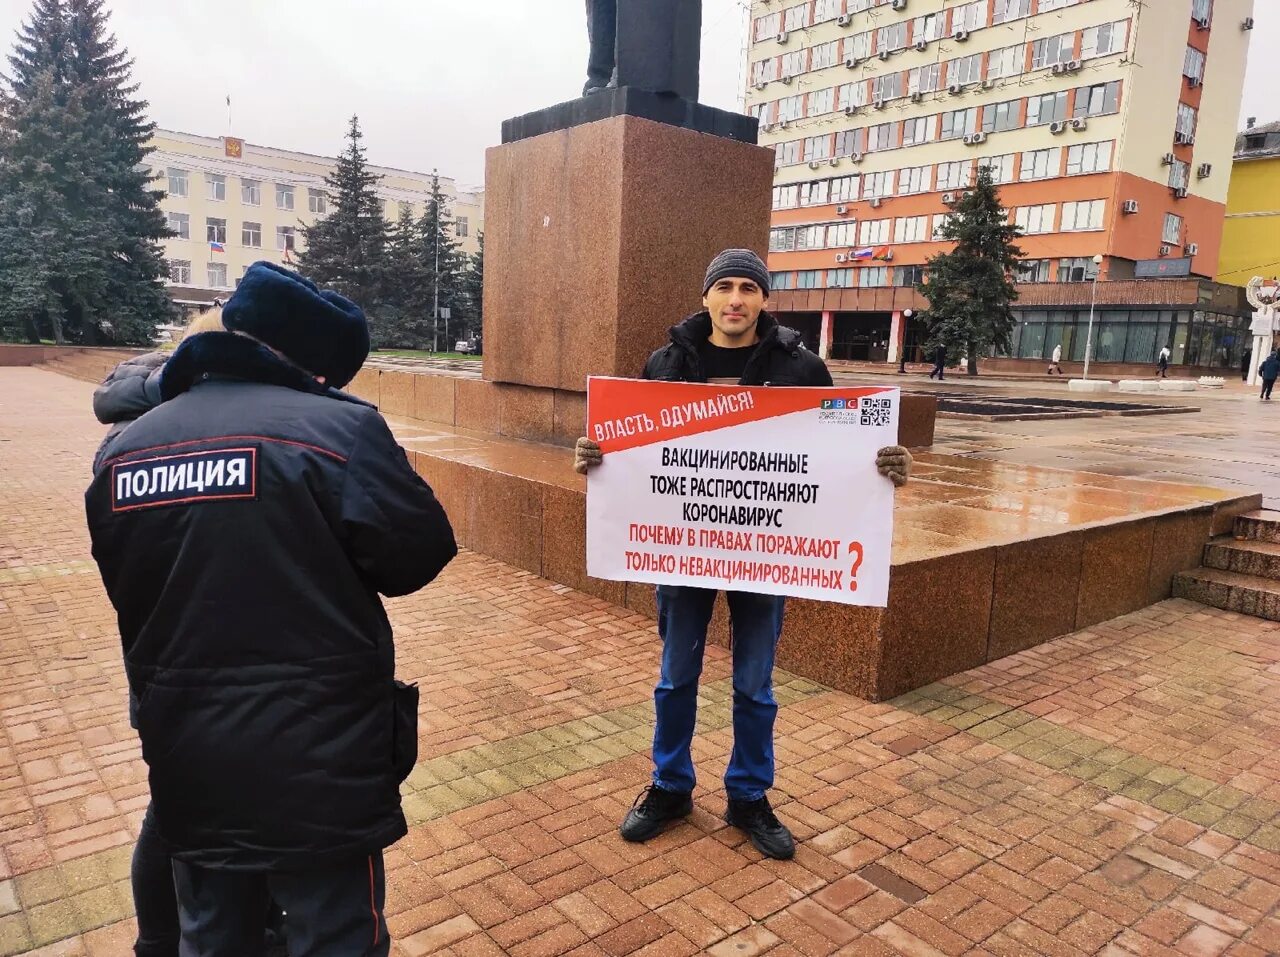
[916,166,1023,375]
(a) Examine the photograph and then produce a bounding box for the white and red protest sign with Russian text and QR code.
[586,377,900,606]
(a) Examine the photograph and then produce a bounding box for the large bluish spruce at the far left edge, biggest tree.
[0,0,175,344]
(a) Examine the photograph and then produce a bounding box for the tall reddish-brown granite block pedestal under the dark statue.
[484,113,773,392]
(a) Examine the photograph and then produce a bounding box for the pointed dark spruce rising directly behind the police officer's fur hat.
[298,116,387,313]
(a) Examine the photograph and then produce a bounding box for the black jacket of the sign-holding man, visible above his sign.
[641,312,832,385]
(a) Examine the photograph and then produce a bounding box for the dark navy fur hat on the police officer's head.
[223,262,369,389]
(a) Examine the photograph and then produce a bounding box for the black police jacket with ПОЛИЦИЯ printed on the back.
[86,333,457,870]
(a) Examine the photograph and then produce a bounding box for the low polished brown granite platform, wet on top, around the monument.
[352,370,1261,701]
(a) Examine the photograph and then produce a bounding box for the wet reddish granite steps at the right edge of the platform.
[1174,510,1280,622]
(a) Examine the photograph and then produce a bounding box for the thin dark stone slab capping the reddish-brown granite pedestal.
[501,86,760,144]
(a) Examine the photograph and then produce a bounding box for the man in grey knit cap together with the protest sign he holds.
[573,249,911,858]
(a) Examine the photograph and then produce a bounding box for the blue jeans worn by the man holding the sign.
[653,585,785,801]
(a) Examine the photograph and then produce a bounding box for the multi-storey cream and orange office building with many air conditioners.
[746,0,1254,367]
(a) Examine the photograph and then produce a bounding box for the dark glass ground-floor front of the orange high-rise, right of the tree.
[1010,308,1251,370]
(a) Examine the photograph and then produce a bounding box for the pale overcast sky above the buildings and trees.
[0,0,1280,184]
